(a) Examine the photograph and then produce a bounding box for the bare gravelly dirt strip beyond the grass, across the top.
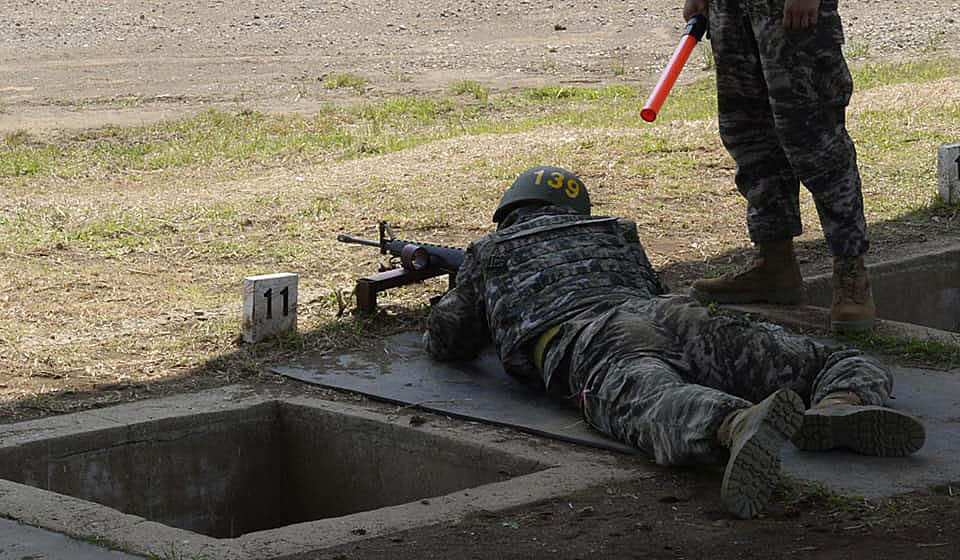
[0,0,960,131]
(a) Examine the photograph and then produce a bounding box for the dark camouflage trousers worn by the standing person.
[710,0,869,256]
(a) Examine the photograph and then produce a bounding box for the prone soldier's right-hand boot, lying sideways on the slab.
[793,391,926,457]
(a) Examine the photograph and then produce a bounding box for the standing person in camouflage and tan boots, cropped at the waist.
[683,0,876,330]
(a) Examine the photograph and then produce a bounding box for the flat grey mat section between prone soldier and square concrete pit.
[271,333,636,453]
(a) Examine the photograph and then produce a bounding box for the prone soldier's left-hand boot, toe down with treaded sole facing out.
[717,389,804,519]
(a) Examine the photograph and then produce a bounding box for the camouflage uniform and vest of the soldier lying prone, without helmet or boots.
[424,206,892,464]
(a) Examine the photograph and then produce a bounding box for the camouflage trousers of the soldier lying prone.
[545,295,893,465]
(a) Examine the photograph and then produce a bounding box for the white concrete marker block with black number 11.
[243,272,300,342]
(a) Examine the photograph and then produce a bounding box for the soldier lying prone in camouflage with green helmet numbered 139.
[424,167,925,518]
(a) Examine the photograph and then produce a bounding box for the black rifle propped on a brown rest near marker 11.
[337,221,464,313]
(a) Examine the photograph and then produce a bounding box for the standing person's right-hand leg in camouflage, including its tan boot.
[753,0,876,329]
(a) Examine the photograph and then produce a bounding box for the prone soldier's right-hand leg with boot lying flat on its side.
[650,296,924,456]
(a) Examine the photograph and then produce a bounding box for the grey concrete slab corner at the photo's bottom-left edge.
[0,519,143,560]
